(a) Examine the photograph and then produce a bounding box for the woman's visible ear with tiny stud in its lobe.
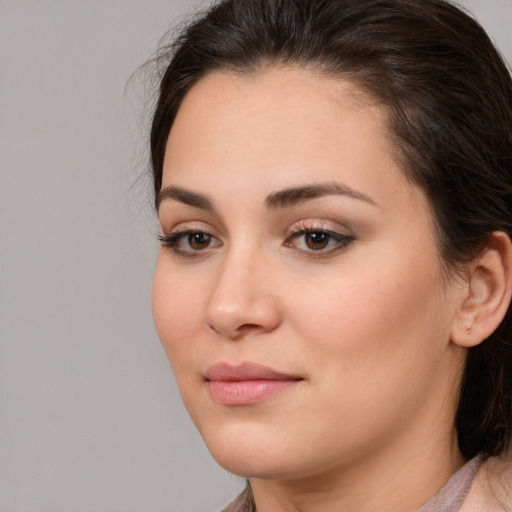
[451,231,512,347]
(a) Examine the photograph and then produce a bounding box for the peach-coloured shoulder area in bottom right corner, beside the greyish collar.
[460,456,512,512]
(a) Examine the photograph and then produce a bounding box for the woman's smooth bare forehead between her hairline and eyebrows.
[163,67,421,216]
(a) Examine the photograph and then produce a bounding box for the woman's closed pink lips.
[205,363,304,406]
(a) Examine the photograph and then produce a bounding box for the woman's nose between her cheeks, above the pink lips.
[205,249,281,339]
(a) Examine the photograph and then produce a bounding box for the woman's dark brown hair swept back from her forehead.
[151,0,512,458]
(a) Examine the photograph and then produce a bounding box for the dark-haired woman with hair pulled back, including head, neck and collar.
[146,0,512,512]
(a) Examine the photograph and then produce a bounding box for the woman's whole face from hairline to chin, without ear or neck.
[153,68,464,479]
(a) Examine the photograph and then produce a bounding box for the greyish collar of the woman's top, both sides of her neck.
[222,457,482,512]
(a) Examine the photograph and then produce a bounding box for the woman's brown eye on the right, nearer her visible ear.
[284,227,354,255]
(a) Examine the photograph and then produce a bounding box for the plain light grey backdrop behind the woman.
[0,0,512,512]
